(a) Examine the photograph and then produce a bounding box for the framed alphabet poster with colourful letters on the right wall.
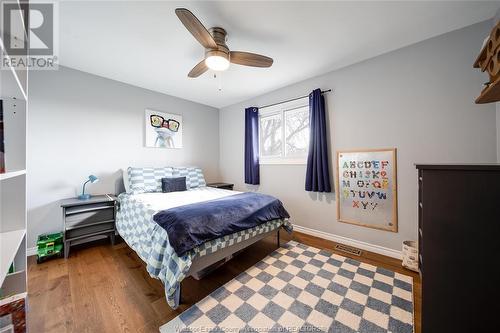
[336,148,398,232]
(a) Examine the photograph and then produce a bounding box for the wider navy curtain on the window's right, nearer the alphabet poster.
[306,89,332,192]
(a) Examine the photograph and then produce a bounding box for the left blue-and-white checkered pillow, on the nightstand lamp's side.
[127,167,174,194]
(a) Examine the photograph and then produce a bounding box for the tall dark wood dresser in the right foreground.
[417,164,500,333]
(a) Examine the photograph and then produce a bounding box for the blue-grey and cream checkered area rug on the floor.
[160,241,413,333]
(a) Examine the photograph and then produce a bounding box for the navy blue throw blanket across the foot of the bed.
[153,193,290,256]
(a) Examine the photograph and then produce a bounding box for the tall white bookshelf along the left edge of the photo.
[0,0,28,312]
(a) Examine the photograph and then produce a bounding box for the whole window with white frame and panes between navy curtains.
[259,97,309,164]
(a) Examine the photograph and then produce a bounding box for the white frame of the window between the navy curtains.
[259,96,309,165]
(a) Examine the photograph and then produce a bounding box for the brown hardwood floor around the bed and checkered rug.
[28,232,421,333]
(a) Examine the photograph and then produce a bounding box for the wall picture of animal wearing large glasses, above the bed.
[146,110,182,148]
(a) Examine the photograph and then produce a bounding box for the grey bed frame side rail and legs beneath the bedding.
[175,227,281,304]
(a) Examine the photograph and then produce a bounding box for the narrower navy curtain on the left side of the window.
[245,107,260,185]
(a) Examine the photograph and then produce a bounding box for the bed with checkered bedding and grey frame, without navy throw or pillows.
[116,168,292,309]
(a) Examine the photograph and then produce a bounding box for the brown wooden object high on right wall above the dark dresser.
[474,22,500,104]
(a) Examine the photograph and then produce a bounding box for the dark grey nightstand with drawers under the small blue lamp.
[61,194,116,258]
